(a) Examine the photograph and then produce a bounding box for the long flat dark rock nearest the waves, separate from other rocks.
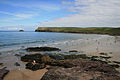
[26,47,61,51]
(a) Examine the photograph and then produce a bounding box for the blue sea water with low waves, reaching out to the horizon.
[0,31,101,53]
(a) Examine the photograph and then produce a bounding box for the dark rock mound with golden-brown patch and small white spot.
[21,53,51,71]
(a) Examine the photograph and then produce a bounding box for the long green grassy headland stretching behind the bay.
[35,27,120,35]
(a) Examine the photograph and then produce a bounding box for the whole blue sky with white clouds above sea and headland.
[0,0,120,30]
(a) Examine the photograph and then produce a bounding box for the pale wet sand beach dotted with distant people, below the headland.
[51,35,120,61]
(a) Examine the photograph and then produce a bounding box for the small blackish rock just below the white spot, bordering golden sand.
[26,62,46,71]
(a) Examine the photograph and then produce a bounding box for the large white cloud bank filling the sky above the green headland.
[40,0,120,27]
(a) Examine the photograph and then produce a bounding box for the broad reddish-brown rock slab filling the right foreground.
[41,59,120,80]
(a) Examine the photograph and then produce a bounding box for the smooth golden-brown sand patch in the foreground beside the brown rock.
[4,69,47,80]
